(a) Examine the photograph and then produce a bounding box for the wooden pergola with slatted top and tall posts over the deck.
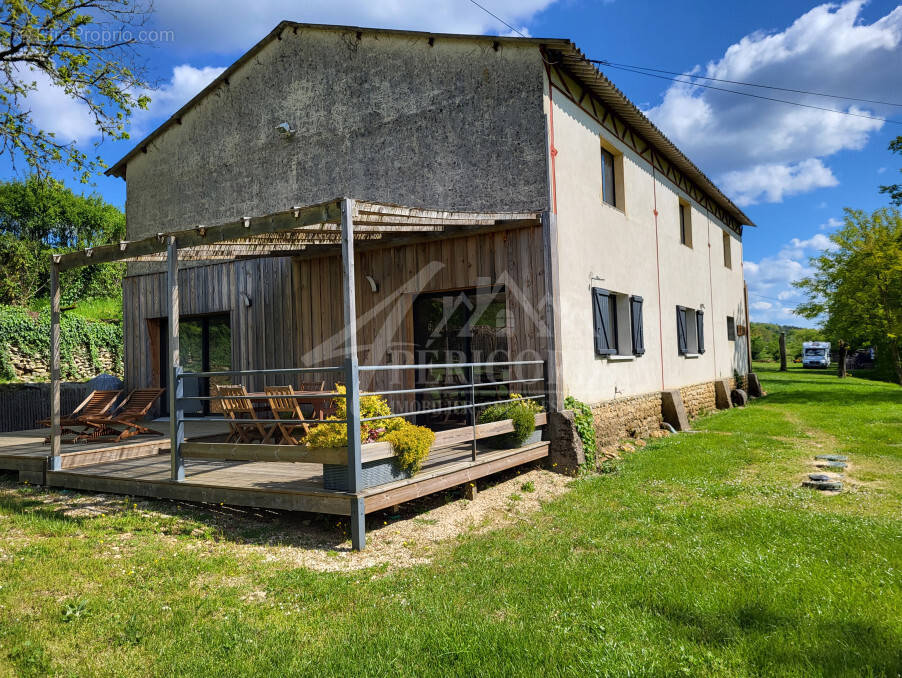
[49,198,557,548]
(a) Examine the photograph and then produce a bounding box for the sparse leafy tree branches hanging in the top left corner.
[0,0,150,182]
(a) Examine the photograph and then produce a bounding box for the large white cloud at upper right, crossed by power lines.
[648,0,902,205]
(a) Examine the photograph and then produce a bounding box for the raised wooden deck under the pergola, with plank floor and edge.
[0,422,548,515]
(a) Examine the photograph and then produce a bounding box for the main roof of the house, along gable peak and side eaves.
[106,21,755,226]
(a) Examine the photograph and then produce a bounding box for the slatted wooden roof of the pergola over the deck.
[53,198,542,271]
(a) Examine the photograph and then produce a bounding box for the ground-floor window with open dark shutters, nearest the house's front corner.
[592,287,645,357]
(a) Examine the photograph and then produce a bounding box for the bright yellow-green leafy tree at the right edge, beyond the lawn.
[795,208,902,384]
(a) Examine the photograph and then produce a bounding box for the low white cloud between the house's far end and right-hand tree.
[742,227,835,326]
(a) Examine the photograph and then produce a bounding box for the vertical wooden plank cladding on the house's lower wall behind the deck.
[123,225,549,410]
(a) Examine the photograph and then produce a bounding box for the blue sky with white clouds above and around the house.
[0,0,902,325]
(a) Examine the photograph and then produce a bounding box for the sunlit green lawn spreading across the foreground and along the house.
[0,368,902,677]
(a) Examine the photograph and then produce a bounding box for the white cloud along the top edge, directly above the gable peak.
[148,0,554,54]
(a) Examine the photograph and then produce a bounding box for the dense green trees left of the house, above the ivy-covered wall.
[0,176,125,306]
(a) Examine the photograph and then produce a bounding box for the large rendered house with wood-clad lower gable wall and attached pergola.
[33,22,752,546]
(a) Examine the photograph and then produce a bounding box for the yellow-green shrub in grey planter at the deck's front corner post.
[304,386,435,491]
